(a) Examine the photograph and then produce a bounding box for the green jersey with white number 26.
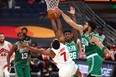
[65,41,78,62]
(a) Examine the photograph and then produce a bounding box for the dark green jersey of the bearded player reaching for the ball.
[81,32,96,56]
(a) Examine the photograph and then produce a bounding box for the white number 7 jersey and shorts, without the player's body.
[51,43,77,77]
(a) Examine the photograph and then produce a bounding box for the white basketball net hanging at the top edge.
[45,0,59,10]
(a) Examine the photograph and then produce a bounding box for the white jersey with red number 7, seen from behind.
[51,43,73,69]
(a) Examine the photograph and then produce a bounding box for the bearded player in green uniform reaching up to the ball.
[58,9,114,77]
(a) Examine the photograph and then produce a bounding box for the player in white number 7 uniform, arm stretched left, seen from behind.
[21,39,82,77]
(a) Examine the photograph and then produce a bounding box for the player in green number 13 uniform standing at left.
[7,32,31,77]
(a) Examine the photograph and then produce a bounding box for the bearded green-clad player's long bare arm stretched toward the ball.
[61,8,83,34]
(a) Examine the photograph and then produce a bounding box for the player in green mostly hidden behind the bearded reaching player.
[96,28,107,58]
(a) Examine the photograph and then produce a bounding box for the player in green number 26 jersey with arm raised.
[63,7,81,63]
